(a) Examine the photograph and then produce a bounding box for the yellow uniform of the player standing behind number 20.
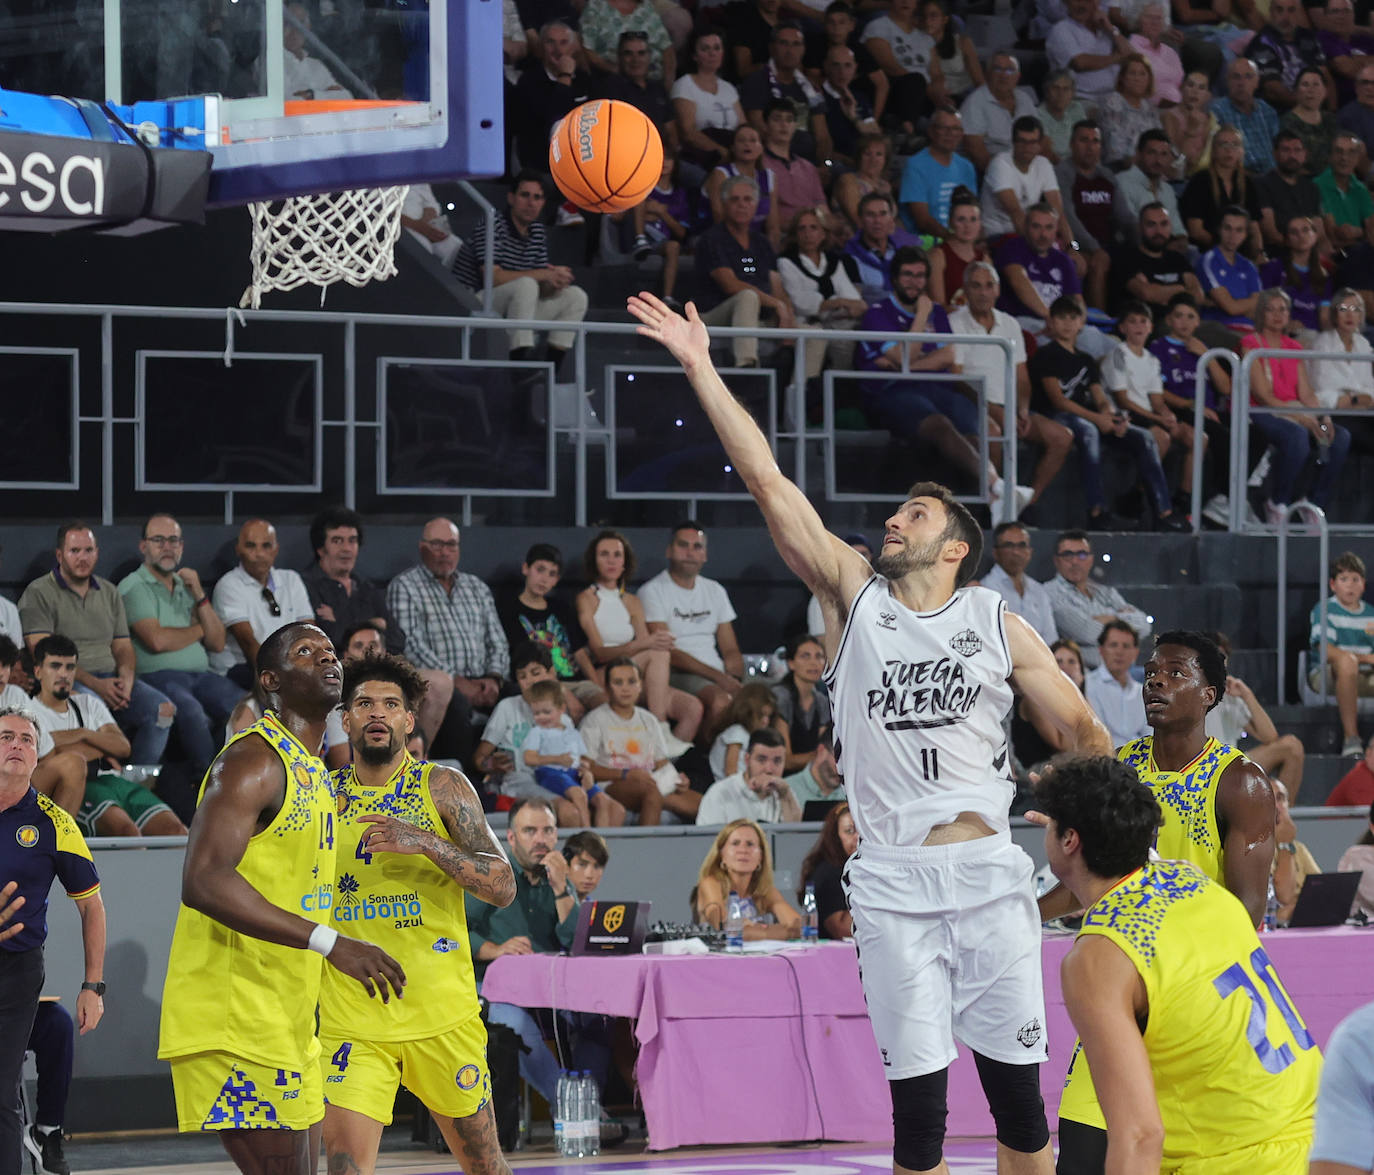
[1059,735,1245,1130]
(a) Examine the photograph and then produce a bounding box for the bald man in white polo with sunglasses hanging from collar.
[210,518,315,690]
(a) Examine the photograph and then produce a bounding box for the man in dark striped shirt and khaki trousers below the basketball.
[453,170,587,372]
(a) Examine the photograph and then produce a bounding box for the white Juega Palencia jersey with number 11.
[826,576,1015,848]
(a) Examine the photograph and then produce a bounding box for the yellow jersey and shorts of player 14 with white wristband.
[158,713,335,1131]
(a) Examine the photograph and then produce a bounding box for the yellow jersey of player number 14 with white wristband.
[158,713,334,1071]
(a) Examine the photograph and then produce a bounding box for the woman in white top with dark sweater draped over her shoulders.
[778,206,867,379]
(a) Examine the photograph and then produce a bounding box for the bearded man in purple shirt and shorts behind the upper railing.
[855,246,1032,508]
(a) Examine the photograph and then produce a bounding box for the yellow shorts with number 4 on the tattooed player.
[320,1016,492,1126]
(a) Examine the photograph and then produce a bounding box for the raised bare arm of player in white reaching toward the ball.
[628,293,872,620]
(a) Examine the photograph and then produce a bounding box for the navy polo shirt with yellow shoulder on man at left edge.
[0,787,100,952]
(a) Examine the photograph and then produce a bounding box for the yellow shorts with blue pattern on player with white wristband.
[172,1039,324,1134]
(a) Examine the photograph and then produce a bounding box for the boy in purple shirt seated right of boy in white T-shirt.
[1150,294,1231,516]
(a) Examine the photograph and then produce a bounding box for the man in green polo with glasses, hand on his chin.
[120,514,243,776]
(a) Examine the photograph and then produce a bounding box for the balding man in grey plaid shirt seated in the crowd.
[386,518,510,759]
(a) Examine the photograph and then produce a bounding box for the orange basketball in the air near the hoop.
[548,98,664,212]
